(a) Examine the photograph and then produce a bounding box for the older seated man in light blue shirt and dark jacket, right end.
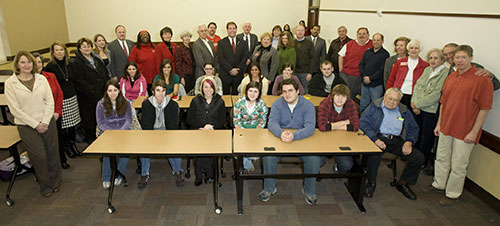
[360,88,424,200]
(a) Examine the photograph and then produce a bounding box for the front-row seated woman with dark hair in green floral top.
[233,81,268,172]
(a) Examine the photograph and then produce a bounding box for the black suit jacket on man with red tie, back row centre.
[217,37,248,78]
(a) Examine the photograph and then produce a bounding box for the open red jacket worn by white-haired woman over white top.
[386,57,429,93]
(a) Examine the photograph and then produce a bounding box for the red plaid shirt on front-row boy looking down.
[317,94,359,132]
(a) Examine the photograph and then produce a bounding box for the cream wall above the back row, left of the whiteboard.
[64,0,307,42]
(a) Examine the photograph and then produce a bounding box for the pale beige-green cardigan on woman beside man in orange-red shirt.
[411,66,449,113]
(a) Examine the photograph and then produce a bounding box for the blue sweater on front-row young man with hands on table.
[267,96,316,140]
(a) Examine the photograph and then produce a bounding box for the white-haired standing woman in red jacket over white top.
[386,40,429,112]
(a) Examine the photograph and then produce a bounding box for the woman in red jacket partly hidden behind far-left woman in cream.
[33,52,72,169]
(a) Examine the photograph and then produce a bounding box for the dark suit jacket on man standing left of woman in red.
[108,39,134,81]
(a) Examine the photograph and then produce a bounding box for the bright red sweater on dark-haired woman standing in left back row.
[128,44,160,84]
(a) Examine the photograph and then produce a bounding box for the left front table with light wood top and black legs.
[83,130,232,214]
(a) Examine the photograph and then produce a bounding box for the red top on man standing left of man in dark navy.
[342,40,373,76]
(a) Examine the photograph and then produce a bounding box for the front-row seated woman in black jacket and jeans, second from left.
[137,79,184,189]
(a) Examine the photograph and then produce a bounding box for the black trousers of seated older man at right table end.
[367,135,424,185]
